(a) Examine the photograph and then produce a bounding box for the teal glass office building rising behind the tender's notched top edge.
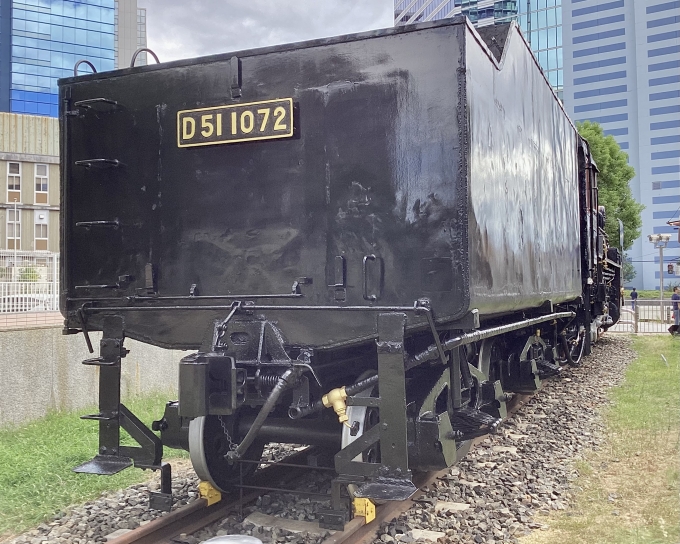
[394,0,564,98]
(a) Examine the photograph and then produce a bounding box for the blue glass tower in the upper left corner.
[0,0,115,116]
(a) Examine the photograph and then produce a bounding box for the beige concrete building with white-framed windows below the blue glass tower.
[0,113,59,252]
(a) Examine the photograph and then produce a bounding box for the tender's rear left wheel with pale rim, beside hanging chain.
[189,416,264,492]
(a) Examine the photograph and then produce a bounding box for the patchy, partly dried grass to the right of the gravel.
[522,336,680,544]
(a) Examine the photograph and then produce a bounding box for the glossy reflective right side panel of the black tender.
[466,27,581,314]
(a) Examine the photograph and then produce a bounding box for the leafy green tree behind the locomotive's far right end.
[576,121,645,251]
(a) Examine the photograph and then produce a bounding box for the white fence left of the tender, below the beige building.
[0,250,59,314]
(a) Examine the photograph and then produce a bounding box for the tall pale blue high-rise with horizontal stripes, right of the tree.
[563,0,680,289]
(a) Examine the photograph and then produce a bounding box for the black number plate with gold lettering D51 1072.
[177,98,293,147]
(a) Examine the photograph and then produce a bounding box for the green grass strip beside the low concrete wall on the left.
[0,394,186,537]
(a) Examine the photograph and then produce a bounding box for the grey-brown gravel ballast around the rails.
[3,335,635,544]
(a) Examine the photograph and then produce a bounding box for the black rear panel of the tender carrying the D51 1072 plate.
[61,21,468,348]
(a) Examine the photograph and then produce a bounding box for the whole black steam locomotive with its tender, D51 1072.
[59,18,621,525]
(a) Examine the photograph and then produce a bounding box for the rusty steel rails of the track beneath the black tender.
[109,395,533,544]
